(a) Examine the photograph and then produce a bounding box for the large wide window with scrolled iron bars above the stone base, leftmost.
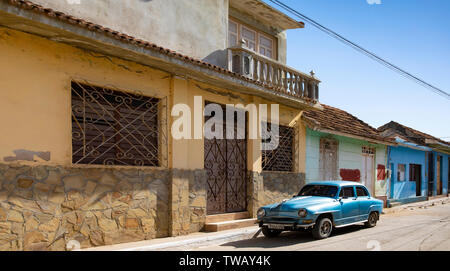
[72,82,160,166]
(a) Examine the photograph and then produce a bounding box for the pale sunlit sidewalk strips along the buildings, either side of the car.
[83,197,450,251]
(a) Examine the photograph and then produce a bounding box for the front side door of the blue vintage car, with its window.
[337,186,359,225]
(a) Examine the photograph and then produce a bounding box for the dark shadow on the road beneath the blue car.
[215,225,364,248]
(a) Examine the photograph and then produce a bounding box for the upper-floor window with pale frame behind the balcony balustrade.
[228,19,276,59]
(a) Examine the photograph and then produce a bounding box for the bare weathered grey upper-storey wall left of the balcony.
[29,0,228,64]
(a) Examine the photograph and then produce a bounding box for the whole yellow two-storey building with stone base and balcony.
[0,0,320,250]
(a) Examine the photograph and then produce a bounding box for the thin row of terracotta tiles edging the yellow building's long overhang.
[0,0,317,104]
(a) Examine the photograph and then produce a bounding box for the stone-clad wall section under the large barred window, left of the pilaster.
[0,165,171,251]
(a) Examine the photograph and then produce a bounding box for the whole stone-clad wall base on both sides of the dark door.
[0,164,305,251]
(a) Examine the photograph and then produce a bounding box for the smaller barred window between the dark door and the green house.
[262,123,295,172]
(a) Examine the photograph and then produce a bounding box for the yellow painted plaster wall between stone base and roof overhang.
[0,25,304,172]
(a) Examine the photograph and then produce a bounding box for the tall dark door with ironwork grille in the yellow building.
[204,103,247,215]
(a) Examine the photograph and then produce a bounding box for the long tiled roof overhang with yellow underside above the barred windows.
[0,0,320,109]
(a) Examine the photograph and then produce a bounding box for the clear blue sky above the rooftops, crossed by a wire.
[265,0,450,141]
